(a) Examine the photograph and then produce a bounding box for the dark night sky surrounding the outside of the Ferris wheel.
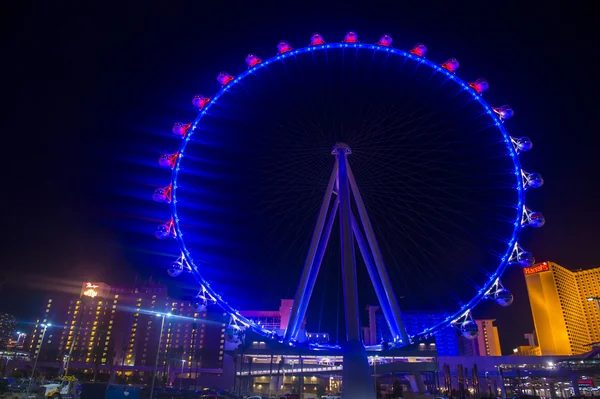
[5,2,600,353]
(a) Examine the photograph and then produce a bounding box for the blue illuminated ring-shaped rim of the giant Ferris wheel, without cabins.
[163,43,526,346]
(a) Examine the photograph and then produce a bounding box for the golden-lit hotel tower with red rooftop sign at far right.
[524,262,600,356]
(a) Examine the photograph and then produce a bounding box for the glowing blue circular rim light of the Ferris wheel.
[165,43,525,346]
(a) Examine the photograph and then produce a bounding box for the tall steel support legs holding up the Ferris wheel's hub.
[284,143,409,399]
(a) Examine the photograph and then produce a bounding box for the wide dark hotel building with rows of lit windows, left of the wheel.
[28,283,226,381]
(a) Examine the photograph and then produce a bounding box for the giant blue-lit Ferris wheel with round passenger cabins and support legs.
[153,32,545,356]
